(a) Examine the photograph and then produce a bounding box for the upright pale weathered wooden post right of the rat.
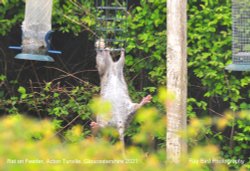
[166,0,187,163]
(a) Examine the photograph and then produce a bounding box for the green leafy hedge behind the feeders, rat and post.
[0,0,250,170]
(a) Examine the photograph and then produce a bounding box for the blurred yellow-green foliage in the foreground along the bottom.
[0,108,250,171]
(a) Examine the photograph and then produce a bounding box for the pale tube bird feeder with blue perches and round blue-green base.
[9,0,61,62]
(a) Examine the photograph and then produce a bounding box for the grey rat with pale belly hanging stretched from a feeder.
[90,39,152,147]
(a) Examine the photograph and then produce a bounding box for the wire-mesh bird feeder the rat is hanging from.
[95,0,128,51]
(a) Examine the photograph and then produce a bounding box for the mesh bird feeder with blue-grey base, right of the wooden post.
[226,0,250,71]
